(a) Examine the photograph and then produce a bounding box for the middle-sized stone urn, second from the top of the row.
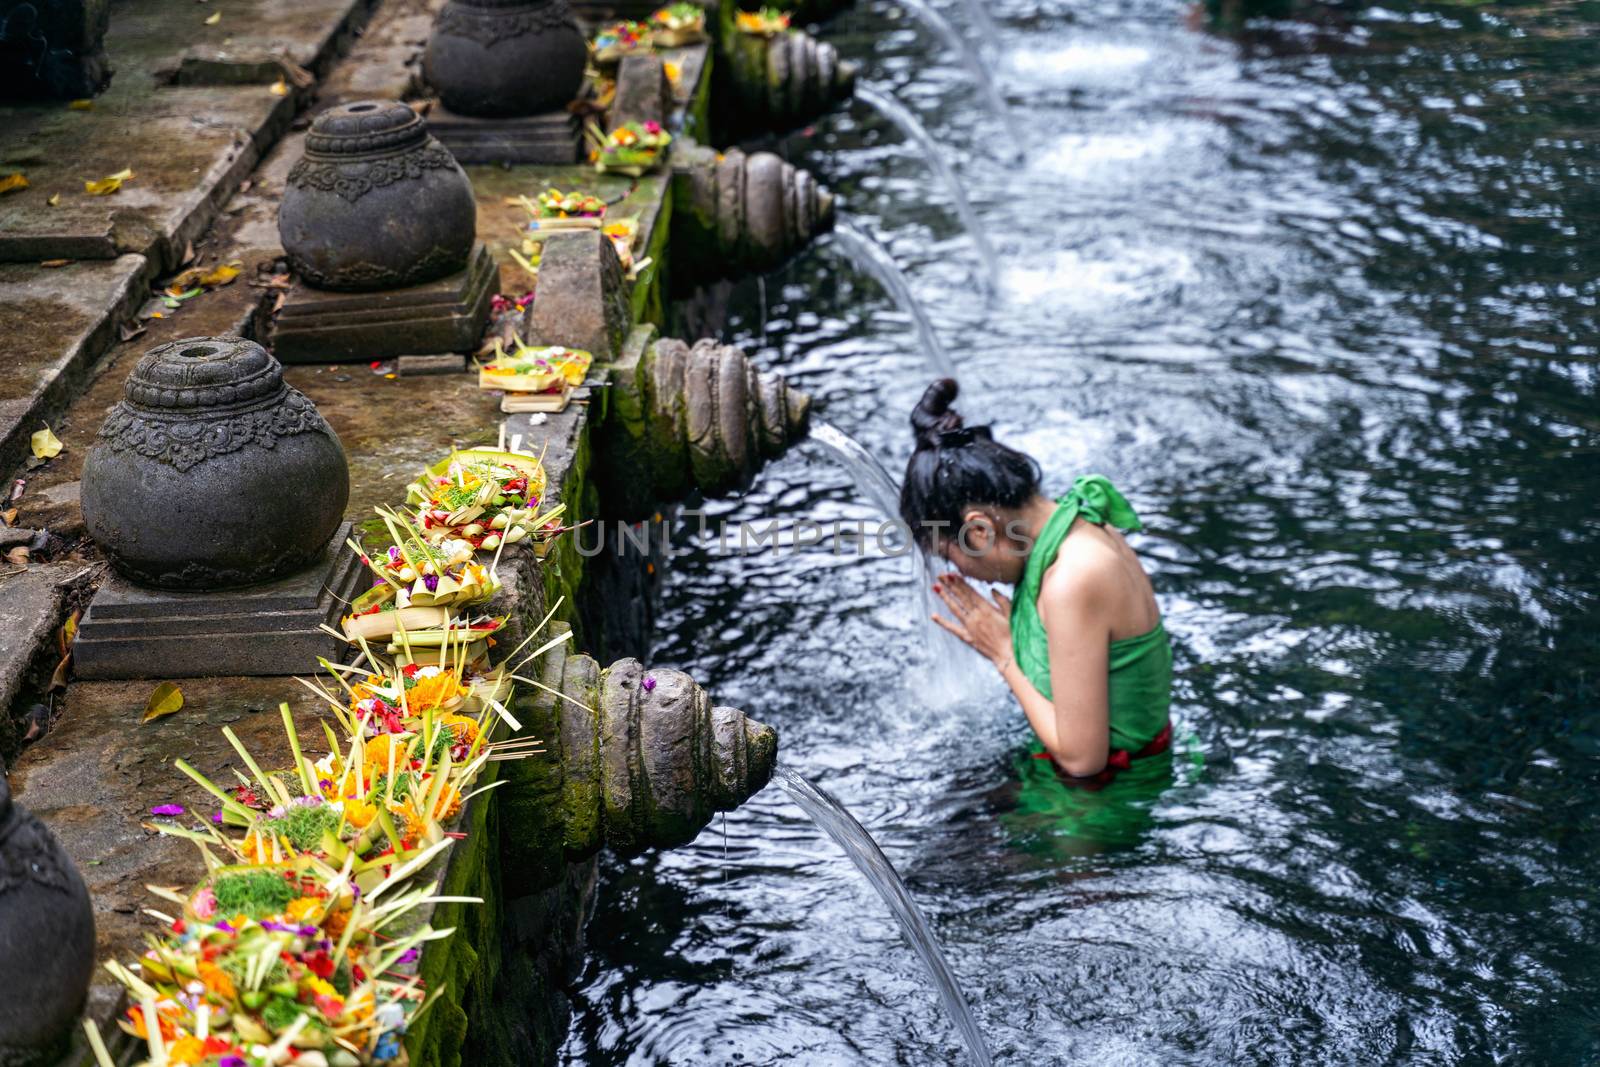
[278,101,477,293]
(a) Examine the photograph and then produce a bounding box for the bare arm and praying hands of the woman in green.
[933,574,1110,776]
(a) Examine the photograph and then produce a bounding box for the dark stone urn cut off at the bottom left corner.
[0,765,94,1067]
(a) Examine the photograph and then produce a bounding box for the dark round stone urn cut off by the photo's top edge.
[422,0,589,118]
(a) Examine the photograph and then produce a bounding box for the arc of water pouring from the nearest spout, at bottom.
[773,766,992,1067]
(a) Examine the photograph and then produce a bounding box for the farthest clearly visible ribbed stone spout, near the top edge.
[725,30,856,131]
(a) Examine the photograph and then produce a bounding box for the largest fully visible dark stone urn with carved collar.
[82,338,350,589]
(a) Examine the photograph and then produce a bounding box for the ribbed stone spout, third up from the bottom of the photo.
[672,142,834,280]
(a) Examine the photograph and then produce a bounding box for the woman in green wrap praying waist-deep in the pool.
[901,378,1173,785]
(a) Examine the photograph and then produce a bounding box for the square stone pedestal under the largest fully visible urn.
[72,523,366,680]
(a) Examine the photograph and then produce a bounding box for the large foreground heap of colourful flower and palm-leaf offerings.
[95,585,571,1067]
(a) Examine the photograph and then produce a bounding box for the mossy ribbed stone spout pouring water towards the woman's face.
[597,328,811,518]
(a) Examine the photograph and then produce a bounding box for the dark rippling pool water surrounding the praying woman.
[565,0,1600,1065]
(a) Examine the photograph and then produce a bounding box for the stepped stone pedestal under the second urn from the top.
[272,243,499,363]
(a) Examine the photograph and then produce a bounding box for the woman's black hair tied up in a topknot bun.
[901,378,1040,549]
